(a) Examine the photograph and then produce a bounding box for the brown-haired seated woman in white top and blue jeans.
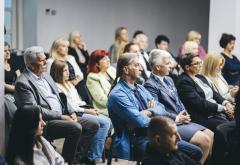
[50,60,111,162]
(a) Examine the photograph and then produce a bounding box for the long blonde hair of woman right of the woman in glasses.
[202,52,225,78]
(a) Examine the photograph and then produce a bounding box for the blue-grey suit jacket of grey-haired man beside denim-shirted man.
[144,74,185,114]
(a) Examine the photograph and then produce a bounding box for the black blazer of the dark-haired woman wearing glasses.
[177,73,224,123]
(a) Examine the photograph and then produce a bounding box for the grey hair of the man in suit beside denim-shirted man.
[149,49,171,69]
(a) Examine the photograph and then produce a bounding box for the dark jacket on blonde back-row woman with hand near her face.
[68,47,89,79]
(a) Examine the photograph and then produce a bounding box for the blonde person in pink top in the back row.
[178,30,206,60]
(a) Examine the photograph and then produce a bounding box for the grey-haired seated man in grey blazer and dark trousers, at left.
[14,46,99,164]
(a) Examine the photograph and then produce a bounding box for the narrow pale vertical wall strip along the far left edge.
[0,0,5,155]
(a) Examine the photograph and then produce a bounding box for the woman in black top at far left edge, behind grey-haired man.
[4,42,20,102]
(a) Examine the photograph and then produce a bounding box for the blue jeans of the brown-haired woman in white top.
[82,114,112,160]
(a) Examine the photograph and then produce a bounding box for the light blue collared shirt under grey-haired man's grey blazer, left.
[27,69,62,114]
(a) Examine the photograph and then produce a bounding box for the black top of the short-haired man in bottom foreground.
[142,144,199,165]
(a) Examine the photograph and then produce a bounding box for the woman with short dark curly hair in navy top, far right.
[219,33,240,85]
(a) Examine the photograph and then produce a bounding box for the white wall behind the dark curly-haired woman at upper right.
[208,0,240,57]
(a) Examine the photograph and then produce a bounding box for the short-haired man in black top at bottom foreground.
[142,116,198,165]
